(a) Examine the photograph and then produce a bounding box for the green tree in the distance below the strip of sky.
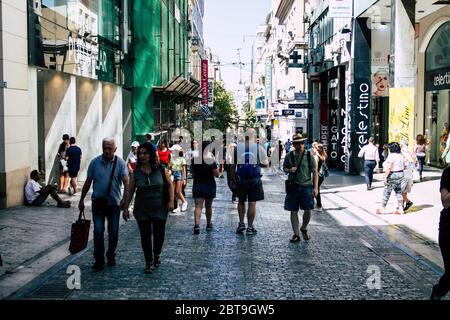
[209,81,238,132]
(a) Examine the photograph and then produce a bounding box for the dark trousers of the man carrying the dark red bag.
[92,201,120,264]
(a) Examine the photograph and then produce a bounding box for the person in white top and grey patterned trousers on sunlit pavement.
[376,142,406,214]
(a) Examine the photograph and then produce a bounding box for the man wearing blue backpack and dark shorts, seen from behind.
[231,129,269,235]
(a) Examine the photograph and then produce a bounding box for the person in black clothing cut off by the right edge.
[430,167,450,300]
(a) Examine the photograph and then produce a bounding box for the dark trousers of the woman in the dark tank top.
[138,220,166,264]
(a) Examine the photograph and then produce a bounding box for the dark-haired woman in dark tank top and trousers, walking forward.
[123,143,174,273]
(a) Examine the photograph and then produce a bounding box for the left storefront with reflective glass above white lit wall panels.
[28,0,131,181]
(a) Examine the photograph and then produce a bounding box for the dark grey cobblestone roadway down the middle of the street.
[6,175,442,300]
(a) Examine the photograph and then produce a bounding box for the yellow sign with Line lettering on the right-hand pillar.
[389,88,415,146]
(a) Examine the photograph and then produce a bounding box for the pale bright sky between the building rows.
[203,0,272,105]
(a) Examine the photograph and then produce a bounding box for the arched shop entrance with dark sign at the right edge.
[424,21,450,166]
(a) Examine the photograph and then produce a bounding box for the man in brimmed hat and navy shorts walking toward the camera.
[283,133,319,243]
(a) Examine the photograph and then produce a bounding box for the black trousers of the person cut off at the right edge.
[434,210,450,297]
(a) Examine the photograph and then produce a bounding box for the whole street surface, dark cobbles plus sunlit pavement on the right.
[0,172,443,300]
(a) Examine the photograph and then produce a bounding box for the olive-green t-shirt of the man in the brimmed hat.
[283,150,317,187]
